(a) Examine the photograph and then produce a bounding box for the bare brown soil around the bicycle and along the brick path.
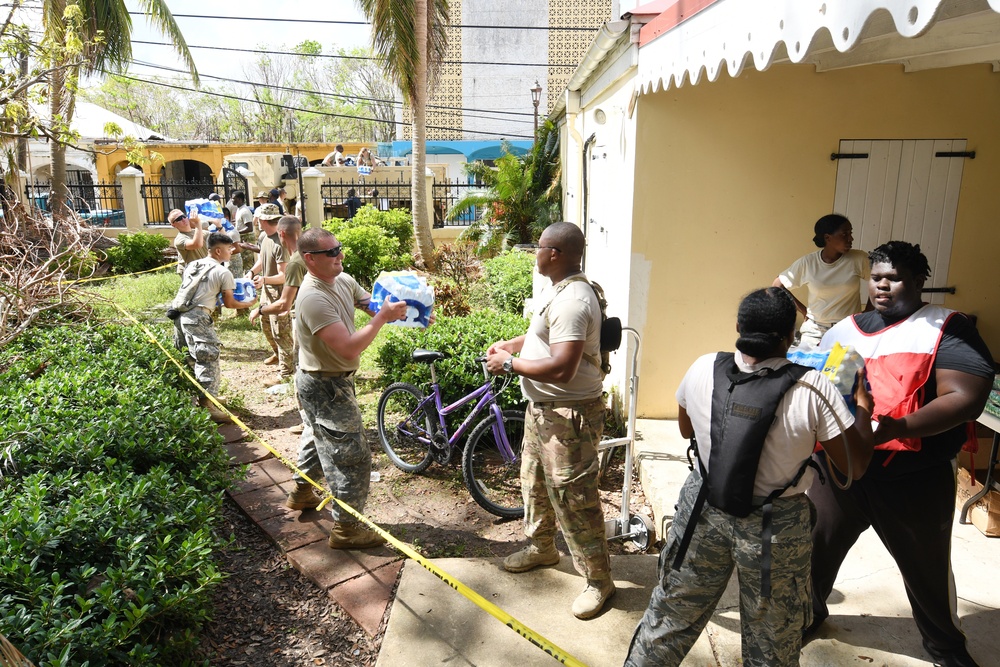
[193,311,650,667]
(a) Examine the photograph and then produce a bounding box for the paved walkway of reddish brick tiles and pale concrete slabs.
[224,420,1000,667]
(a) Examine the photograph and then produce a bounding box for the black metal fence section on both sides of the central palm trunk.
[320,178,481,227]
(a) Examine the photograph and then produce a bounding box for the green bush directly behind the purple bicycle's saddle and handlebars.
[377,310,528,408]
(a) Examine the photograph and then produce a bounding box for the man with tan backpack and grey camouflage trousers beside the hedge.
[173,232,257,423]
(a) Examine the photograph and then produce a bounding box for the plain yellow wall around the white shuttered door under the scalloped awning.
[632,65,1000,417]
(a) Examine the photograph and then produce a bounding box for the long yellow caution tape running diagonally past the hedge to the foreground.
[105,304,587,667]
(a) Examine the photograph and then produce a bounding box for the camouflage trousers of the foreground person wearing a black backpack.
[625,470,812,667]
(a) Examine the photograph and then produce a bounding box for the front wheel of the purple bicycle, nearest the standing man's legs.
[462,410,524,519]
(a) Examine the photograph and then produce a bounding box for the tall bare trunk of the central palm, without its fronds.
[410,0,434,268]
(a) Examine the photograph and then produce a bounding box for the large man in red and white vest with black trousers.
[809,241,994,667]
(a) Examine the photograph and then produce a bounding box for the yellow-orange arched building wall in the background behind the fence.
[95,142,376,186]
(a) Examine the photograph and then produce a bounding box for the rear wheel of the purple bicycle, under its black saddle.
[378,382,434,472]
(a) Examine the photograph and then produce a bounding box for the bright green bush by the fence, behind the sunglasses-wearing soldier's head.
[323,206,413,290]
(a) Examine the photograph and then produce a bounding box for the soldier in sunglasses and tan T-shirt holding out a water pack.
[286,229,407,549]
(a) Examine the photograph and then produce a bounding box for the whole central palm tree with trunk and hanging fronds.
[357,0,448,265]
